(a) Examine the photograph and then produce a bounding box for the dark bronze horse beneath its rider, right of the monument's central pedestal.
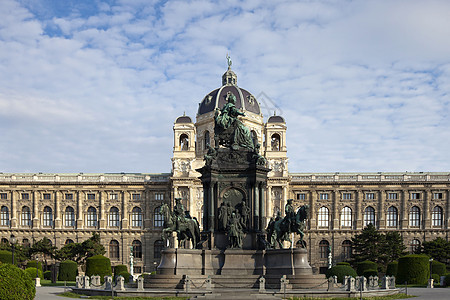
[267,205,309,249]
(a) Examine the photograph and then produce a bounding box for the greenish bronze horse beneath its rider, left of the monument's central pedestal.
[159,204,200,248]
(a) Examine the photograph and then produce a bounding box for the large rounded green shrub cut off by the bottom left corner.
[0,264,36,300]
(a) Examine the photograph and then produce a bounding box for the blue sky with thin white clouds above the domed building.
[0,0,450,173]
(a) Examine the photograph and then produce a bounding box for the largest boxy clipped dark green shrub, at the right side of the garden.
[396,254,430,284]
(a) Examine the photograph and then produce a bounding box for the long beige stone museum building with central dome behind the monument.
[0,67,450,273]
